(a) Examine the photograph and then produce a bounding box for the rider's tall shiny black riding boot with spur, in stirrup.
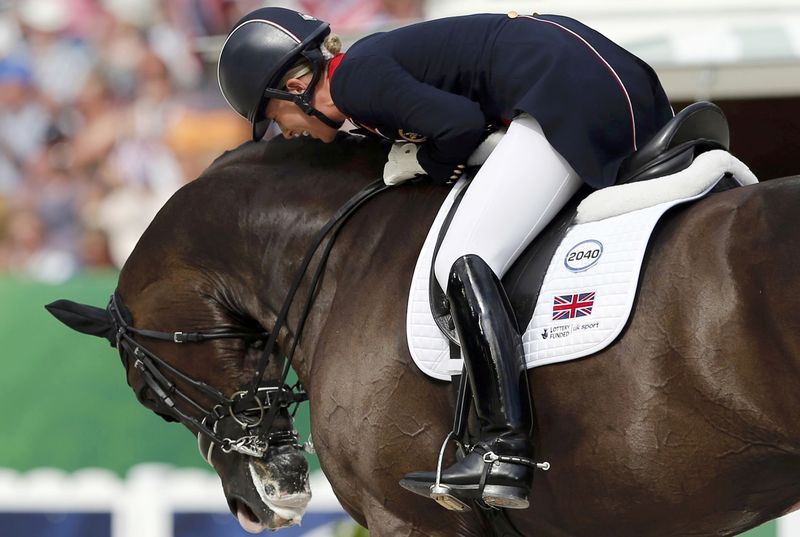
[400,255,533,509]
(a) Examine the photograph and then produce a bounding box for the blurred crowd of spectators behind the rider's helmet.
[0,0,422,282]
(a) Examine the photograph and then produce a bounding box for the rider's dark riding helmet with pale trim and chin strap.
[217,7,341,140]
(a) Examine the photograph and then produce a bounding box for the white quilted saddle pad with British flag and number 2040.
[407,150,758,380]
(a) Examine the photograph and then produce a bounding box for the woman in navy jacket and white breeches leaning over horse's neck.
[218,7,672,508]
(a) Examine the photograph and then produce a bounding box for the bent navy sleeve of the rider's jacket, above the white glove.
[331,56,486,183]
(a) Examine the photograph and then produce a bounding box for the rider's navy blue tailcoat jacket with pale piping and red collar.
[331,14,673,188]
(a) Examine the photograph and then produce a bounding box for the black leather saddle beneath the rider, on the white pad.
[429,101,735,341]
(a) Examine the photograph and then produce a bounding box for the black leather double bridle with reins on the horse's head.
[107,179,389,457]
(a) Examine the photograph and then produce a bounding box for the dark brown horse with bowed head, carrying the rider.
[48,133,800,537]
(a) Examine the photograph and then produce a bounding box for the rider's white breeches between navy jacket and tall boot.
[434,114,582,290]
